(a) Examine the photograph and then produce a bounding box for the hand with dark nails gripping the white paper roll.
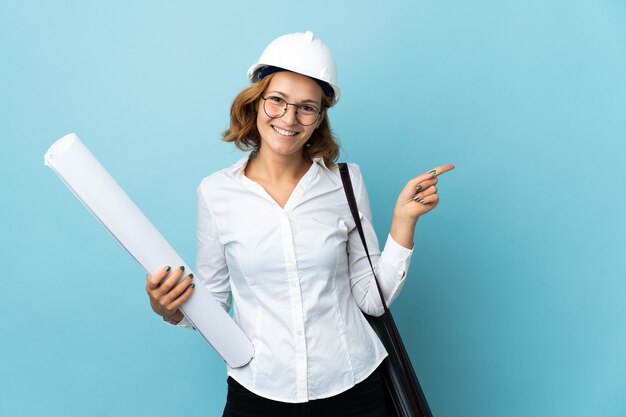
[146,266,196,324]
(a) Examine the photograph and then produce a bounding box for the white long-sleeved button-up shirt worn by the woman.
[180,157,412,403]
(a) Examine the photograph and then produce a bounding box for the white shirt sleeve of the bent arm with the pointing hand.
[348,164,413,316]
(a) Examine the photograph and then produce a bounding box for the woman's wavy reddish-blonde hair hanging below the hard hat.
[222,74,339,167]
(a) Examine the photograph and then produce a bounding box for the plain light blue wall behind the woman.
[0,0,626,417]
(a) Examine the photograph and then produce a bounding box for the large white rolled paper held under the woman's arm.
[44,133,254,368]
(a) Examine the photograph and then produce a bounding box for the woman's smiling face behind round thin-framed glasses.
[256,71,324,162]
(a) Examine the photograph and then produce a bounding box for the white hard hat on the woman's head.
[248,31,341,103]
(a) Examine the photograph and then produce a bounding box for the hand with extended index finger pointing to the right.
[390,164,454,249]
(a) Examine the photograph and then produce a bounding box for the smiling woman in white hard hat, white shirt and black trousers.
[146,32,453,417]
